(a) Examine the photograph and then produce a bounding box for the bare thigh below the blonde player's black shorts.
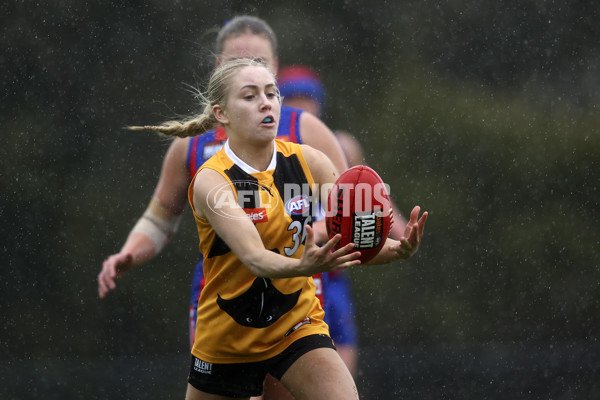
[281,348,358,400]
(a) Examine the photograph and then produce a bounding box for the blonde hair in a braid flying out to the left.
[127,58,275,138]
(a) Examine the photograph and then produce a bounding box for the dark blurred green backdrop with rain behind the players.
[0,0,600,400]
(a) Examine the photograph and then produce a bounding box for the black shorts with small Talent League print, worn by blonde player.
[188,335,335,397]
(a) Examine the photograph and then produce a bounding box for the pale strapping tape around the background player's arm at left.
[131,197,181,254]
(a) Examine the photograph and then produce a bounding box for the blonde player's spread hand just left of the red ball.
[298,225,360,276]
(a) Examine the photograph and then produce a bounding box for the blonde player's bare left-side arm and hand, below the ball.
[193,164,359,278]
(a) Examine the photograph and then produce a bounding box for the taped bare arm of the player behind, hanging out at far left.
[98,139,190,298]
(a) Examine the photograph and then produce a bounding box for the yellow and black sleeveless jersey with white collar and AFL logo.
[188,140,329,363]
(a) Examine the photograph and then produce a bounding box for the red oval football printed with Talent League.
[325,165,392,263]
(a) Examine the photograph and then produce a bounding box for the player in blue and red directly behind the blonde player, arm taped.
[98,16,347,398]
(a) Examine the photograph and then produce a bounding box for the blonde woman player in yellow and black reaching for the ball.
[136,59,427,399]
